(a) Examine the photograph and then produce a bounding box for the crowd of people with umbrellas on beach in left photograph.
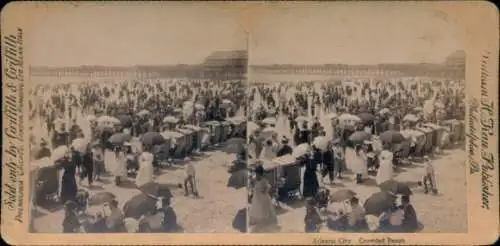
[29,79,245,233]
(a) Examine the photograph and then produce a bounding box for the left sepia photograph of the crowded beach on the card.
[26,4,248,233]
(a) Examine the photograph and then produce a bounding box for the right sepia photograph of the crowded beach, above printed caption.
[247,3,467,233]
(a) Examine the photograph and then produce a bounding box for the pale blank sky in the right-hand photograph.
[249,2,462,65]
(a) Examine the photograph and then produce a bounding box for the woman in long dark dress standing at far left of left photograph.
[56,154,78,203]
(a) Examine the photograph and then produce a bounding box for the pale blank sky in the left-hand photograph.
[29,2,247,67]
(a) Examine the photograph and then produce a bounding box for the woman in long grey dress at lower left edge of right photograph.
[249,166,278,230]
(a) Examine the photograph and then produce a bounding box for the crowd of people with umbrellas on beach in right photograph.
[248,77,465,232]
